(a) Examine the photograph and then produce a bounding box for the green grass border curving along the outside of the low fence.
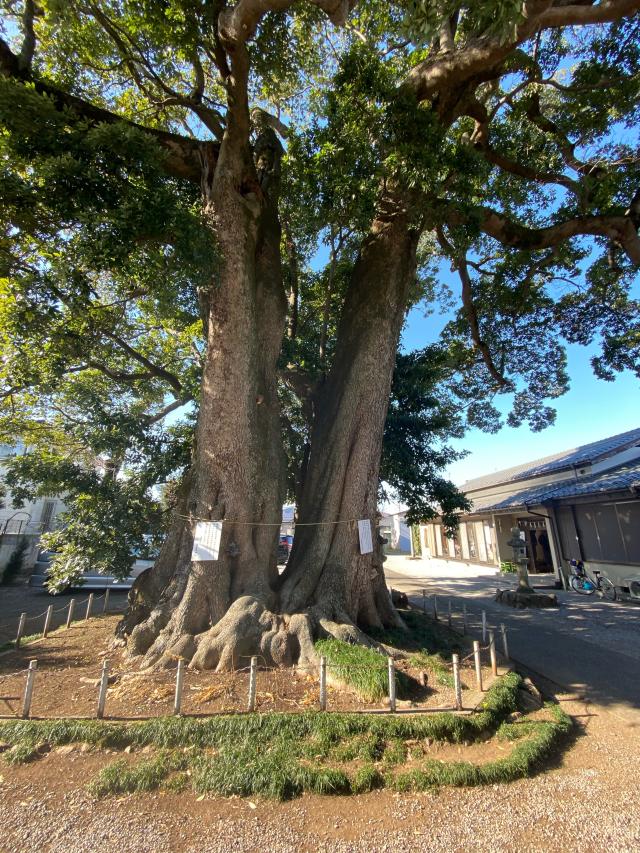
[0,673,570,800]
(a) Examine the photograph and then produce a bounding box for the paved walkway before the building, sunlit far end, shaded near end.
[385,557,640,725]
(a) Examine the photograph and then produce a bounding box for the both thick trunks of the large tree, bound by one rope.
[124,175,418,668]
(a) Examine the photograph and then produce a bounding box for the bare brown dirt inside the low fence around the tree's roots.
[0,616,490,719]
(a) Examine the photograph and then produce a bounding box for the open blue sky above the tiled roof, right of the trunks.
[402,296,640,484]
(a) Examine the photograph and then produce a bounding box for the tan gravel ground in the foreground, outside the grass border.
[0,697,640,853]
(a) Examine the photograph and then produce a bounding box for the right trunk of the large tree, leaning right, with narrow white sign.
[281,191,419,634]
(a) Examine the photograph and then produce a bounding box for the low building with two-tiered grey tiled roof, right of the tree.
[421,428,640,589]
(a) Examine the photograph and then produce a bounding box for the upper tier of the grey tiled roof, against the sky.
[460,428,640,494]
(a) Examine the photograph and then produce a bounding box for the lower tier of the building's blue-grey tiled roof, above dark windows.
[472,459,640,513]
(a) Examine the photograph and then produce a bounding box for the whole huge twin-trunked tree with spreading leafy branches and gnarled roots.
[0,0,640,669]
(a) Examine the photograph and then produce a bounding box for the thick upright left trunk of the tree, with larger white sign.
[122,90,286,667]
